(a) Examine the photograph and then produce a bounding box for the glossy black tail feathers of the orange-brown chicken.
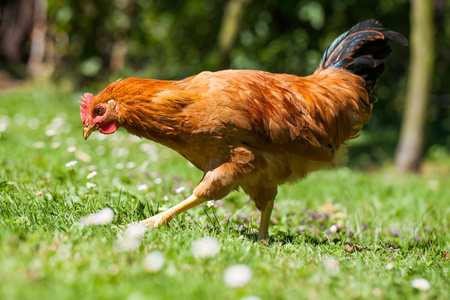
[318,20,408,92]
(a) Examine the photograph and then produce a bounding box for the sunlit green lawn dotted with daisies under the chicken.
[0,82,450,300]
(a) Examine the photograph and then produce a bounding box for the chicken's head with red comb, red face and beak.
[80,93,119,139]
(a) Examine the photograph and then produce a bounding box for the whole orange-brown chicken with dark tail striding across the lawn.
[80,20,408,239]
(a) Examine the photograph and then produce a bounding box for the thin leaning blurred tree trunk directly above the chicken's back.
[219,0,251,69]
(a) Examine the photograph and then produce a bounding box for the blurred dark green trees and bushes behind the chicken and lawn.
[0,0,450,172]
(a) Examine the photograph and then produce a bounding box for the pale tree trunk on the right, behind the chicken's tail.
[395,0,435,172]
